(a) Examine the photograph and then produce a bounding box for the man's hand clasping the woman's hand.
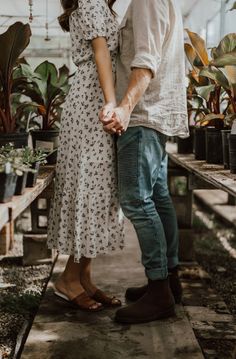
[101,106,130,135]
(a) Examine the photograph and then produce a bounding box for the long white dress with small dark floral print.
[48,0,124,262]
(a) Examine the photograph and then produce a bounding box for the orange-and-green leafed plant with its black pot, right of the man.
[185,30,236,164]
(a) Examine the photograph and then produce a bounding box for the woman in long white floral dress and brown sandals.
[48,0,124,311]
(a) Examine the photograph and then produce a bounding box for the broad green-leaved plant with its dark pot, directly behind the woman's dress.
[16,61,70,163]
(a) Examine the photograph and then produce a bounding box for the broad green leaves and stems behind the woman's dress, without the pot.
[14,61,70,131]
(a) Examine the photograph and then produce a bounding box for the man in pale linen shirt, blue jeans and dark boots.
[101,0,188,323]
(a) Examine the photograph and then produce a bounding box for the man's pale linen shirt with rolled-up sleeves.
[117,0,189,137]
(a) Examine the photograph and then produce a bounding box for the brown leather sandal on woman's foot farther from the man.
[54,290,103,312]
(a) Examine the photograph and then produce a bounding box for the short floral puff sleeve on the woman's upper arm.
[78,0,108,40]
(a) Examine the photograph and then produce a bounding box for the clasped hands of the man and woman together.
[99,104,130,136]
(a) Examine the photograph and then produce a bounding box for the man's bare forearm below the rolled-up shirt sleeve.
[119,68,152,114]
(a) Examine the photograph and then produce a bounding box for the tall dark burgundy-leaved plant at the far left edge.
[0,22,31,133]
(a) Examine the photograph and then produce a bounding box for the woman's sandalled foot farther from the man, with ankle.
[54,275,102,312]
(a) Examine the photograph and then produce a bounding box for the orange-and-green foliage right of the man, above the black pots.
[185,29,236,128]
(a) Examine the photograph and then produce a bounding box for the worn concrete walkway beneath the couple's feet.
[21,224,203,359]
